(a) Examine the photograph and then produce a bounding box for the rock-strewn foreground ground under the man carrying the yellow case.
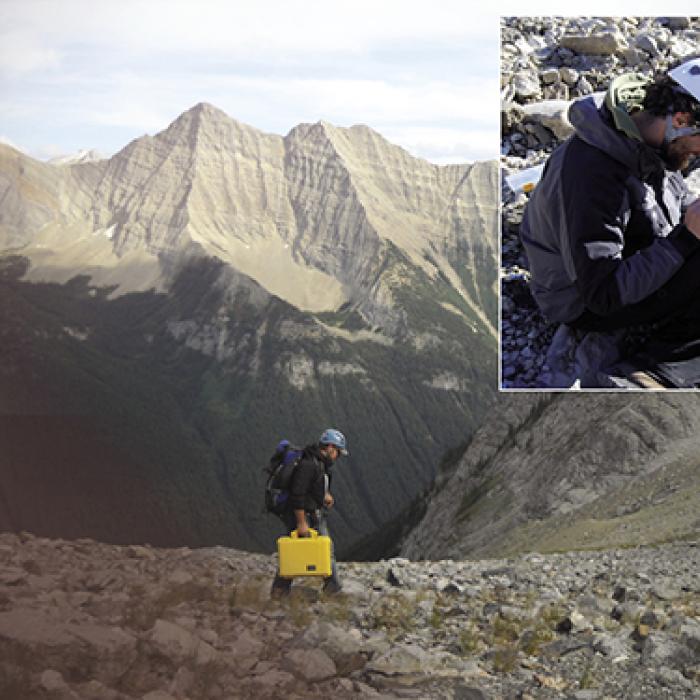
[0,533,700,700]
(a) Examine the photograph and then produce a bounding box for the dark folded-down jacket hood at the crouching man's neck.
[569,93,664,179]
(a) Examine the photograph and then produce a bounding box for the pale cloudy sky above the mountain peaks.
[0,0,690,163]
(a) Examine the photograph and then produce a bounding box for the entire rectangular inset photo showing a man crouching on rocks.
[499,17,700,391]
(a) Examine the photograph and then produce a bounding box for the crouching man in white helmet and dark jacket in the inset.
[521,58,700,332]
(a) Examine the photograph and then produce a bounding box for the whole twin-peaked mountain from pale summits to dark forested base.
[0,104,497,557]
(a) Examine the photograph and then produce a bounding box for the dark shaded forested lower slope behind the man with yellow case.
[0,253,494,553]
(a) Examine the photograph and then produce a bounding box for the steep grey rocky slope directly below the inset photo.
[403,394,700,558]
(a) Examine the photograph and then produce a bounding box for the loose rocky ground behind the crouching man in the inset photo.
[501,17,700,388]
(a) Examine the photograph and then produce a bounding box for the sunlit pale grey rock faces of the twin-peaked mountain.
[0,102,496,320]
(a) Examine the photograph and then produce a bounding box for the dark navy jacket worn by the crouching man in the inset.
[520,91,698,322]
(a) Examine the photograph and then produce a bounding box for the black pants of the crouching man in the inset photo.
[567,246,700,334]
